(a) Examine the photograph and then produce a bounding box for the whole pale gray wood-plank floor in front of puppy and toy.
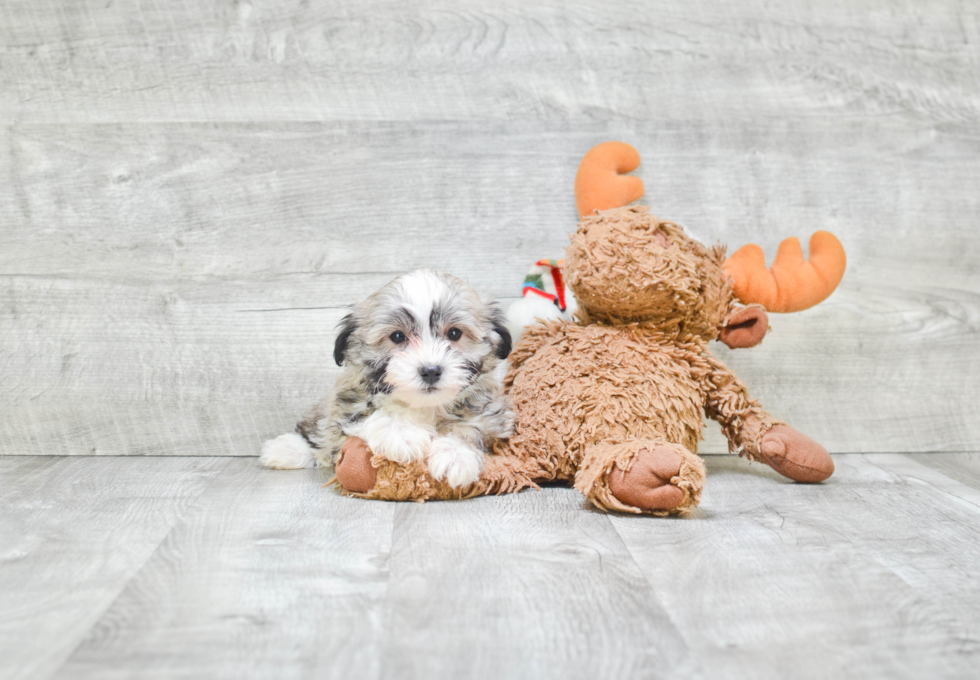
[0,454,980,680]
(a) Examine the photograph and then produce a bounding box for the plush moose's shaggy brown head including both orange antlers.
[565,142,846,347]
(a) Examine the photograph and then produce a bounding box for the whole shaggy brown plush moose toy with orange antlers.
[336,142,845,515]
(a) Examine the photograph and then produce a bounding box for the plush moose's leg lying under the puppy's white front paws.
[336,437,537,501]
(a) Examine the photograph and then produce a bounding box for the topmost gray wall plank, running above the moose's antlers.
[0,0,980,124]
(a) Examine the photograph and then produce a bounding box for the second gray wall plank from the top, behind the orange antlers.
[0,122,980,290]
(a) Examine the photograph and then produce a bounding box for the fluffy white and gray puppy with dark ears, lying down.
[260,269,514,487]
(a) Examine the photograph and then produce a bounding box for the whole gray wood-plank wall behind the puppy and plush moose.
[0,0,980,455]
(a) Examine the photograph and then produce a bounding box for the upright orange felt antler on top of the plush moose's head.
[575,142,643,217]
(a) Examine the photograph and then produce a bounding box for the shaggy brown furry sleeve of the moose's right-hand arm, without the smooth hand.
[704,354,785,460]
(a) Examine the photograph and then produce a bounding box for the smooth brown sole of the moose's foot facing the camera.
[609,446,686,510]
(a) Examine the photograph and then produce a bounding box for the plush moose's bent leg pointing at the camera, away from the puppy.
[575,439,704,515]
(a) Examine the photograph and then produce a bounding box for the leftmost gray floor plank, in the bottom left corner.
[0,456,227,680]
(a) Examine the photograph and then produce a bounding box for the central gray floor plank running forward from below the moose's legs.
[382,488,697,678]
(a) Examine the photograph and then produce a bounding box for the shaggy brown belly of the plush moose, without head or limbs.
[510,324,705,464]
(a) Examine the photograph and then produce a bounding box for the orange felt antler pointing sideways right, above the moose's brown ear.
[725,231,847,312]
